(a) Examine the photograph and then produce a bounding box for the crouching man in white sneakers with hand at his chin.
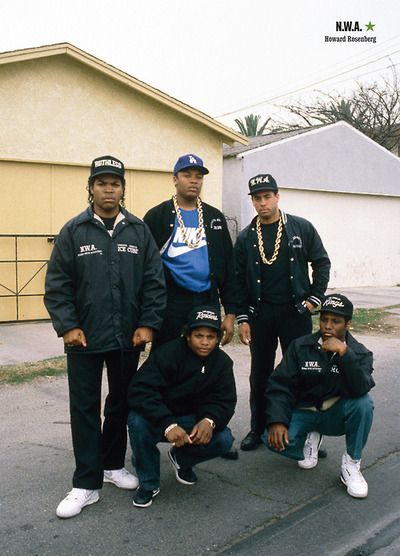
[266,294,375,498]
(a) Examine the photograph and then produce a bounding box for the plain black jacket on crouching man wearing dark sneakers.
[128,338,236,430]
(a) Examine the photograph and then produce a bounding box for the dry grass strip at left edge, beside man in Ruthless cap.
[0,355,67,385]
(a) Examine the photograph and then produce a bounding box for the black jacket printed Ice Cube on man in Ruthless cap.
[44,207,166,353]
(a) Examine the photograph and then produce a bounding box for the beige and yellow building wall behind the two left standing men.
[0,55,234,321]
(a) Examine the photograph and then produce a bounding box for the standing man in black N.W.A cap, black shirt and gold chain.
[235,174,330,450]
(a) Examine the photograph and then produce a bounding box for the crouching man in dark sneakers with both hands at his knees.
[128,306,236,508]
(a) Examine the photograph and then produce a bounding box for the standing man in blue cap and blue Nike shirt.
[144,154,236,349]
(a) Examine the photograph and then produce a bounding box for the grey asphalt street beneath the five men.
[0,328,400,556]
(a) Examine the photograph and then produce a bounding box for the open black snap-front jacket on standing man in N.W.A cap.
[235,210,331,323]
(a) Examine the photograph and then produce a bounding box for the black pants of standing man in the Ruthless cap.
[67,350,139,490]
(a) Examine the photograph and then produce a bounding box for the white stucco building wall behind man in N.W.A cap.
[222,123,400,288]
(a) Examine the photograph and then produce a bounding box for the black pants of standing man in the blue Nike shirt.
[152,284,219,350]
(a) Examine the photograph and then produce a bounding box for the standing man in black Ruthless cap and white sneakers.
[44,155,165,518]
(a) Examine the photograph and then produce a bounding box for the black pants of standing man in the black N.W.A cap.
[250,303,312,434]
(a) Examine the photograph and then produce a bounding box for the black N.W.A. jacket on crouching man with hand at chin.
[266,332,375,426]
